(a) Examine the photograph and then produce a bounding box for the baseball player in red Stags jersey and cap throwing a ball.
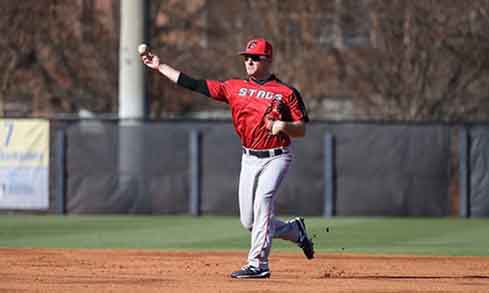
[139,38,314,278]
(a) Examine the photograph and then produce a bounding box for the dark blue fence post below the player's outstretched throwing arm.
[189,129,202,216]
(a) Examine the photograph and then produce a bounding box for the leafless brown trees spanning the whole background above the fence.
[0,0,489,121]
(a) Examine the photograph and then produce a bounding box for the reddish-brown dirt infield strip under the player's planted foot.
[0,249,489,293]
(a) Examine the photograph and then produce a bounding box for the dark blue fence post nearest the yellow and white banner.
[55,128,66,215]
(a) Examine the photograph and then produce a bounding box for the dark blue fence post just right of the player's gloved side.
[323,133,336,218]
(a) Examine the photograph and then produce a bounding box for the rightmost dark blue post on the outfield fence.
[458,125,470,218]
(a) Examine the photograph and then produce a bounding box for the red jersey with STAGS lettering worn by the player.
[206,75,309,150]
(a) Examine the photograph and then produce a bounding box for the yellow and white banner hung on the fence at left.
[0,119,49,209]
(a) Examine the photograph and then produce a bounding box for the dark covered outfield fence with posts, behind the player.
[40,120,489,217]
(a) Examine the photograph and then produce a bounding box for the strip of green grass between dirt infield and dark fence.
[0,215,489,256]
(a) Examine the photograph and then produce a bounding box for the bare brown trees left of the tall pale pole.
[0,0,117,115]
